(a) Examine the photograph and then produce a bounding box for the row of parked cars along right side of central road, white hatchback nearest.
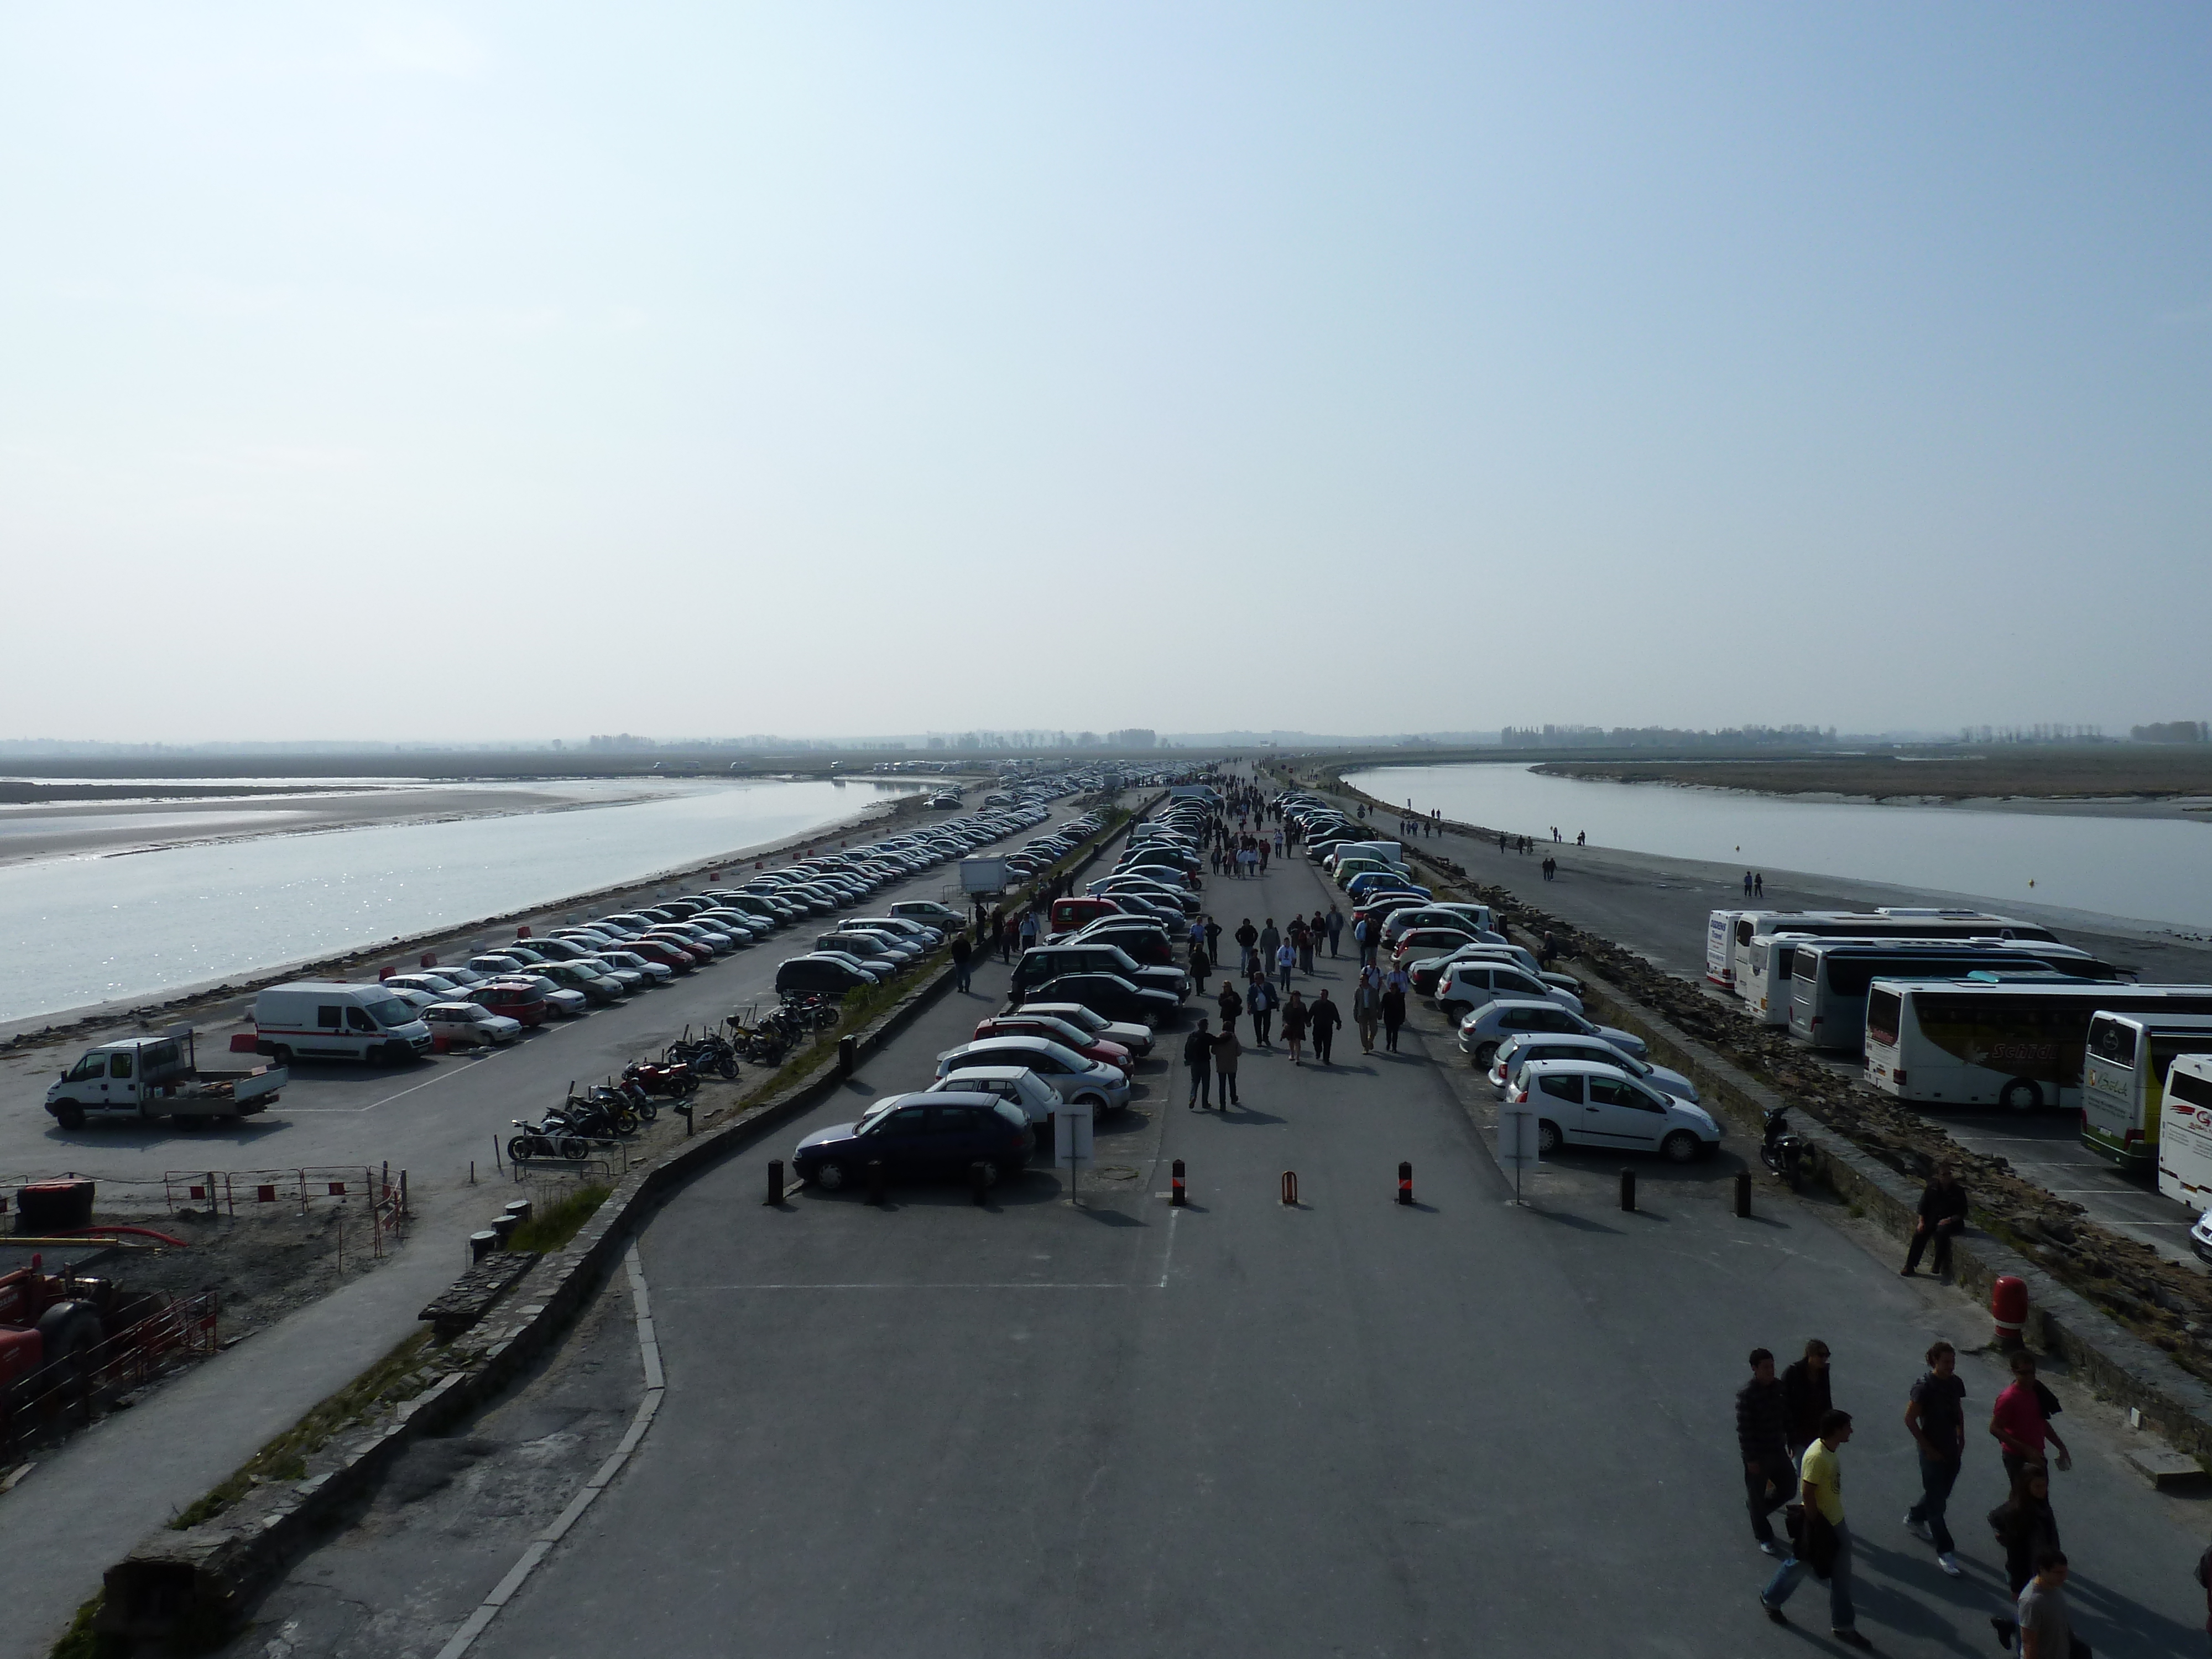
[1283,794,1721,1161]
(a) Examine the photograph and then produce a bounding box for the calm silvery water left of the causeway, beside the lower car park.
[0,783,891,1020]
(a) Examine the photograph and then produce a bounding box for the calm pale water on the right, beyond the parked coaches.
[1349,761,2212,931]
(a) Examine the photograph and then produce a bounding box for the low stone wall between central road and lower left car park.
[95,792,1164,1641]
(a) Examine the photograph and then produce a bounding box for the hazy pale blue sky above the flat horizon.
[0,0,2212,741]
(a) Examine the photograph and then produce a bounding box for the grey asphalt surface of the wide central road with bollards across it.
[254,814,2212,1659]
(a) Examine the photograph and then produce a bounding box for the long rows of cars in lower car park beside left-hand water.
[341,801,1066,1048]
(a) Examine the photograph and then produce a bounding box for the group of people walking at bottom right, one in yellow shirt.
[1736,1336,2097,1659]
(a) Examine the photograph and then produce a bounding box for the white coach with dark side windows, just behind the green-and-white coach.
[1867,973,2212,1113]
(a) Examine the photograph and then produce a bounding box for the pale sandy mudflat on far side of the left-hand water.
[0,781,666,865]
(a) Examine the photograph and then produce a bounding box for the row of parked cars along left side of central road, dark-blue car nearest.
[792,801,1206,1192]
